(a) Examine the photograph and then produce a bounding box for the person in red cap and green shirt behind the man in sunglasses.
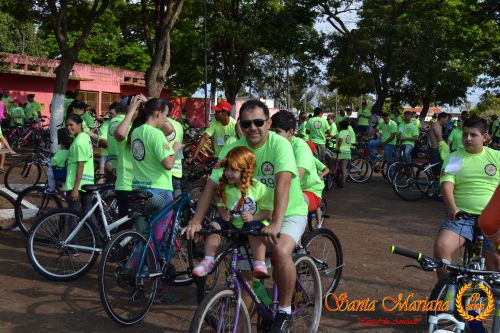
[187,101,236,163]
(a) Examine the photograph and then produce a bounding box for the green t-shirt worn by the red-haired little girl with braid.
[217,179,274,230]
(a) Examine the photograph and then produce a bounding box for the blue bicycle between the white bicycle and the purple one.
[98,191,201,326]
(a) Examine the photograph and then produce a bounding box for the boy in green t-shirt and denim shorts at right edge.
[434,117,500,278]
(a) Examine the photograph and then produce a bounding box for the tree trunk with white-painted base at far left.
[50,52,76,153]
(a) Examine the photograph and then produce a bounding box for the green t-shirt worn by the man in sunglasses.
[210,132,308,216]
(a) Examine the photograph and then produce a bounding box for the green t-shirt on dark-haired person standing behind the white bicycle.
[64,133,94,191]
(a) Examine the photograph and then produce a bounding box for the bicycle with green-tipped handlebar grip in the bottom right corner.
[391,245,500,333]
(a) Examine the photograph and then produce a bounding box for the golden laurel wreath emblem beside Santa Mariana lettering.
[456,283,495,321]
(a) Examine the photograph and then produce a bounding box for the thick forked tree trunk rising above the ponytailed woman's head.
[141,0,184,97]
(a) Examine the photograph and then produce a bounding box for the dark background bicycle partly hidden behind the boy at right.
[392,163,440,201]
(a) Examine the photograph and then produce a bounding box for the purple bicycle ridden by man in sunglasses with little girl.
[189,229,322,333]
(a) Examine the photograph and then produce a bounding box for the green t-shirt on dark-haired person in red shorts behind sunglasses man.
[291,137,325,198]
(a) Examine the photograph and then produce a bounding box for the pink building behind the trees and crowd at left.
[0,53,210,127]
